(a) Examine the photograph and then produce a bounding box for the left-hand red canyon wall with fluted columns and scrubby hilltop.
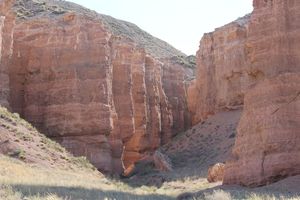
[9,0,193,173]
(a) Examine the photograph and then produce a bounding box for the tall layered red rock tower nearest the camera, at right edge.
[224,0,300,186]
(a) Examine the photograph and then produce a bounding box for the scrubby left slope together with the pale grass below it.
[0,106,171,200]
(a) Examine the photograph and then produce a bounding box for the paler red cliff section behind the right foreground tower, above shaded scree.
[188,15,252,124]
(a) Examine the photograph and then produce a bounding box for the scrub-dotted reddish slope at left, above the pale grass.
[0,106,95,171]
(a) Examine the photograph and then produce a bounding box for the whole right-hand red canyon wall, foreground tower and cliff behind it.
[188,0,300,186]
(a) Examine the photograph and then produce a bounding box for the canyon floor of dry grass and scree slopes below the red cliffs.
[0,108,300,200]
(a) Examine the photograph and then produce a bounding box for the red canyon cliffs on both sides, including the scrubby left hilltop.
[0,0,300,191]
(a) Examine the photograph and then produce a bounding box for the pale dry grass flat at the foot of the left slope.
[0,156,173,200]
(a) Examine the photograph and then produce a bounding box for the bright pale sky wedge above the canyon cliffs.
[69,0,253,55]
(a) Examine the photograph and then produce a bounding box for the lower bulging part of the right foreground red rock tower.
[224,73,300,186]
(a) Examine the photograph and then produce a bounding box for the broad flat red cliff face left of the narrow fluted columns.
[10,14,122,171]
